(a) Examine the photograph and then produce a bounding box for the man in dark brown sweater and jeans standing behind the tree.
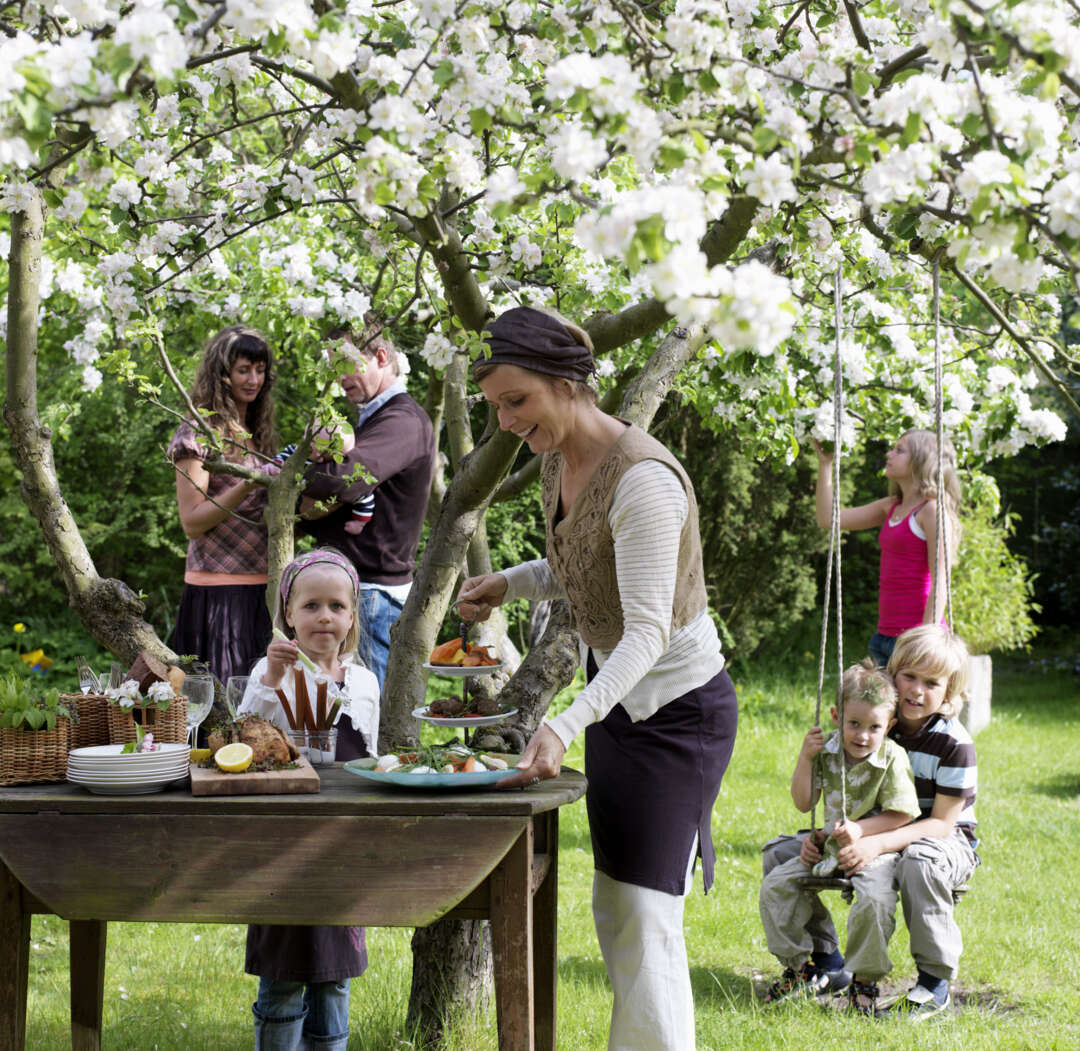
[300,318,435,687]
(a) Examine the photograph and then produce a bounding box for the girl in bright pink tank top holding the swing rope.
[814,431,960,668]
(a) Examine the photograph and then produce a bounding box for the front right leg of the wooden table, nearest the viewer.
[488,821,536,1051]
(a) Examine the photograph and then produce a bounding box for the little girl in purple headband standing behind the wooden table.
[240,548,379,1051]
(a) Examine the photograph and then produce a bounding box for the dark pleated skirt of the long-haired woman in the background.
[168,584,272,683]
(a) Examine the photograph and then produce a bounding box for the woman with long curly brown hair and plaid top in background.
[168,325,278,682]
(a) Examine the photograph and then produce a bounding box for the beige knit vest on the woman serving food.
[541,426,706,650]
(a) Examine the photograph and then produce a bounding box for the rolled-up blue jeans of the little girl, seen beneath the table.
[252,978,349,1051]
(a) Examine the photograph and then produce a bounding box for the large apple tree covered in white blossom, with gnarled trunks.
[0,0,1080,1032]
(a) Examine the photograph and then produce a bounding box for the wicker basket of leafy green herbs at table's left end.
[0,674,78,784]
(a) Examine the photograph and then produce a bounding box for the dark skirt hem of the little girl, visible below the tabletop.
[244,924,367,982]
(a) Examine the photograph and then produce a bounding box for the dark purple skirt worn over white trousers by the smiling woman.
[585,655,739,894]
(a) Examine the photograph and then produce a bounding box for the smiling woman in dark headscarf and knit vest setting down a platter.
[459,307,738,1051]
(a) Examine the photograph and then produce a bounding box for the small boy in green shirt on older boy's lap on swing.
[759,660,919,1010]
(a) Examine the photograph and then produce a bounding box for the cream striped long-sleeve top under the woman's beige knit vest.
[503,460,724,745]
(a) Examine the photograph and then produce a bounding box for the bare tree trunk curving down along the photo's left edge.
[3,190,170,664]
